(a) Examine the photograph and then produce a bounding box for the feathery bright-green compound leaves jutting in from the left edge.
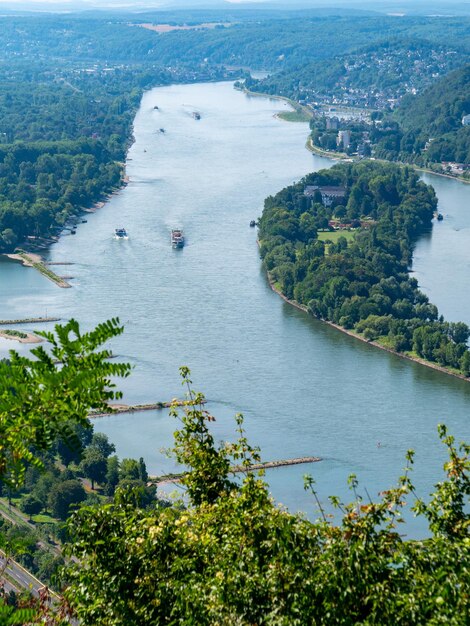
[0,319,129,489]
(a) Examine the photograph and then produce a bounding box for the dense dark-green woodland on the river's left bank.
[0,65,150,251]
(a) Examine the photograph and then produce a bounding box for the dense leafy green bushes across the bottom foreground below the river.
[60,370,470,626]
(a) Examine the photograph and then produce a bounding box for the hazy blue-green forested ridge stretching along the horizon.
[0,12,470,70]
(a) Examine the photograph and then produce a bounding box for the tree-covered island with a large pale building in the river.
[259,161,470,376]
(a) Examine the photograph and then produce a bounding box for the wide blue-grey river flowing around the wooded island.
[0,83,470,536]
